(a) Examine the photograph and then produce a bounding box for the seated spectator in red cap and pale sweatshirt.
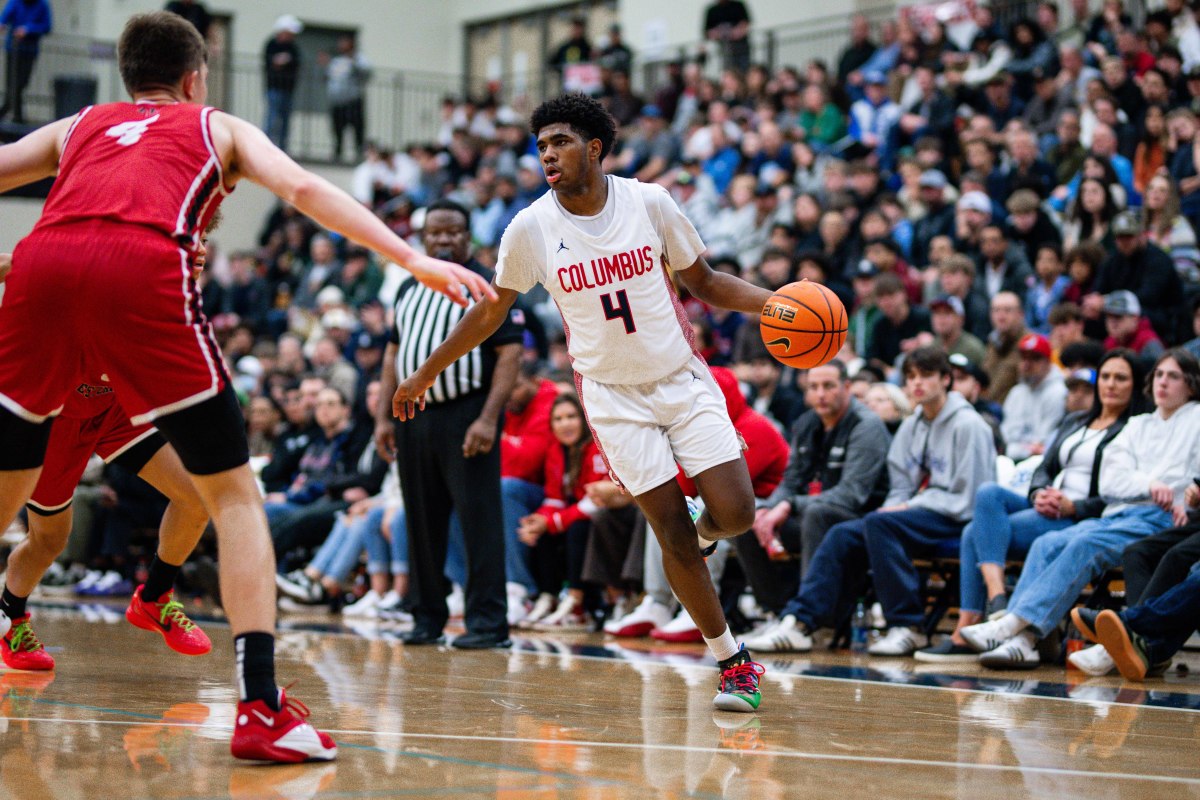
[1000,333,1067,461]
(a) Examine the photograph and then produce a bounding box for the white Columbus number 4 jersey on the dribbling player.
[496,176,704,384]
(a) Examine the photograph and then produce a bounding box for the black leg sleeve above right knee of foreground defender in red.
[155,385,250,475]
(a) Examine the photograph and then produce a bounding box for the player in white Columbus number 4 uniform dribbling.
[392,95,770,711]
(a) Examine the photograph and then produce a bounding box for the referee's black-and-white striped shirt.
[390,259,524,403]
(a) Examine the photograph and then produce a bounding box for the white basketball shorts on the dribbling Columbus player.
[575,355,742,497]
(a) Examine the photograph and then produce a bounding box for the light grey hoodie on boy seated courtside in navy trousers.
[883,392,996,523]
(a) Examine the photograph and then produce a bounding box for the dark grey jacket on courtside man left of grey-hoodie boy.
[768,399,892,513]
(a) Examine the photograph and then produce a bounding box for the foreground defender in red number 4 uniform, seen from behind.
[0,12,496,760]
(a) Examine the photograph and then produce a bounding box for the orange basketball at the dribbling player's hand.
[758,281,850,369]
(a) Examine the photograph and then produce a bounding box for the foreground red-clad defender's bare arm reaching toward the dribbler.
[212,113,496,306]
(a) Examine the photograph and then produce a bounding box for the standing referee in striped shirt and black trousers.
[376,200,524,649]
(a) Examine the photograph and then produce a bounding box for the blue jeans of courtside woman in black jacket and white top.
[959,483,1075,614]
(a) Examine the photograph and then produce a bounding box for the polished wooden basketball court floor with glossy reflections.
[7,606,1200,800]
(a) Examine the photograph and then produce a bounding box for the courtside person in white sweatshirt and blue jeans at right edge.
[960,348,1200,669]
